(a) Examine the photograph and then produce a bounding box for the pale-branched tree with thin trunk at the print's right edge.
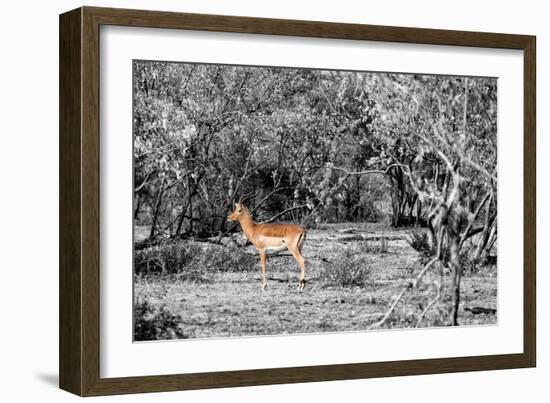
[370,75,496,325]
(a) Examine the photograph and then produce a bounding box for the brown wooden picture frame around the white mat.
[59,7,536,396]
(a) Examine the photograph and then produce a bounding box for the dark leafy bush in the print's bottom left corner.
[134,301,188,341]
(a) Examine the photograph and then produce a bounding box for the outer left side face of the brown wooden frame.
[59,10,83,394]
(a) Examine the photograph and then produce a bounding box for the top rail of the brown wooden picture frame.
[85,7,529,49]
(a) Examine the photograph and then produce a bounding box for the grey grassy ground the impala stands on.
[134,223,497,338]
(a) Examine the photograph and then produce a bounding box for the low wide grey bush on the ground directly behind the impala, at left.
[134,241,257,282]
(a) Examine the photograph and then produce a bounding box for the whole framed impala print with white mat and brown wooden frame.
[60,7,536,396]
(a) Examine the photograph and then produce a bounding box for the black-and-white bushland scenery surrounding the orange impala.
[133,60,498,341]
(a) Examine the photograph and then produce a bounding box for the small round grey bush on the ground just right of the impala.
[320,248,371,287]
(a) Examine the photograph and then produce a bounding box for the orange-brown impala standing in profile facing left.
[227,195,306,291]
